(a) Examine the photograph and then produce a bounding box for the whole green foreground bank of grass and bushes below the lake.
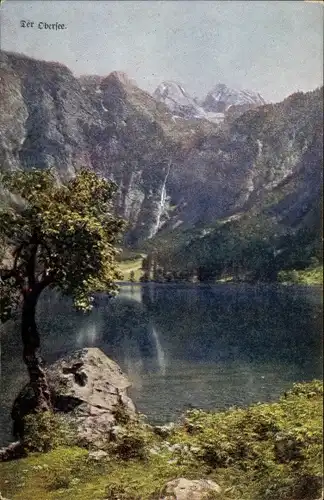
[0,381,323,500]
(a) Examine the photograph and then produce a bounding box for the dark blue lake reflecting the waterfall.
[0,284,322,444]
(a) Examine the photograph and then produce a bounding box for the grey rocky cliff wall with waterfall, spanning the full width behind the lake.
[0,53,323,248]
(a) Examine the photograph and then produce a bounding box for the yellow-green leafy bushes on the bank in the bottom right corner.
[173,381,323,500]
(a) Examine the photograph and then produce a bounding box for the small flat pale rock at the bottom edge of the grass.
[160,477,221,500]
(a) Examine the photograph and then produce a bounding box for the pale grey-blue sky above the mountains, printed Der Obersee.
[0,0,324,101]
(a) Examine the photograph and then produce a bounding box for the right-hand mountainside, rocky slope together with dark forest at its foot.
[154,89,323,280]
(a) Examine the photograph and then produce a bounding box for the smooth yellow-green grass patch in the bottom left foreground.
[0,447,187,500]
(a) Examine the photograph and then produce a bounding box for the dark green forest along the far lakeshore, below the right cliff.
[143,209,323,284]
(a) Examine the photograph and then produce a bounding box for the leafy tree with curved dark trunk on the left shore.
[0,169,124,410]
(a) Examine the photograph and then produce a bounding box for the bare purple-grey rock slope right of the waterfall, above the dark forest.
[161,90,323,237]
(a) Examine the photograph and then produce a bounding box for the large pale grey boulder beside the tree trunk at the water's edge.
[12,347,137,448]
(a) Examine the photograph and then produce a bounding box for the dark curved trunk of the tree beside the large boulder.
[21,291,51,411]
